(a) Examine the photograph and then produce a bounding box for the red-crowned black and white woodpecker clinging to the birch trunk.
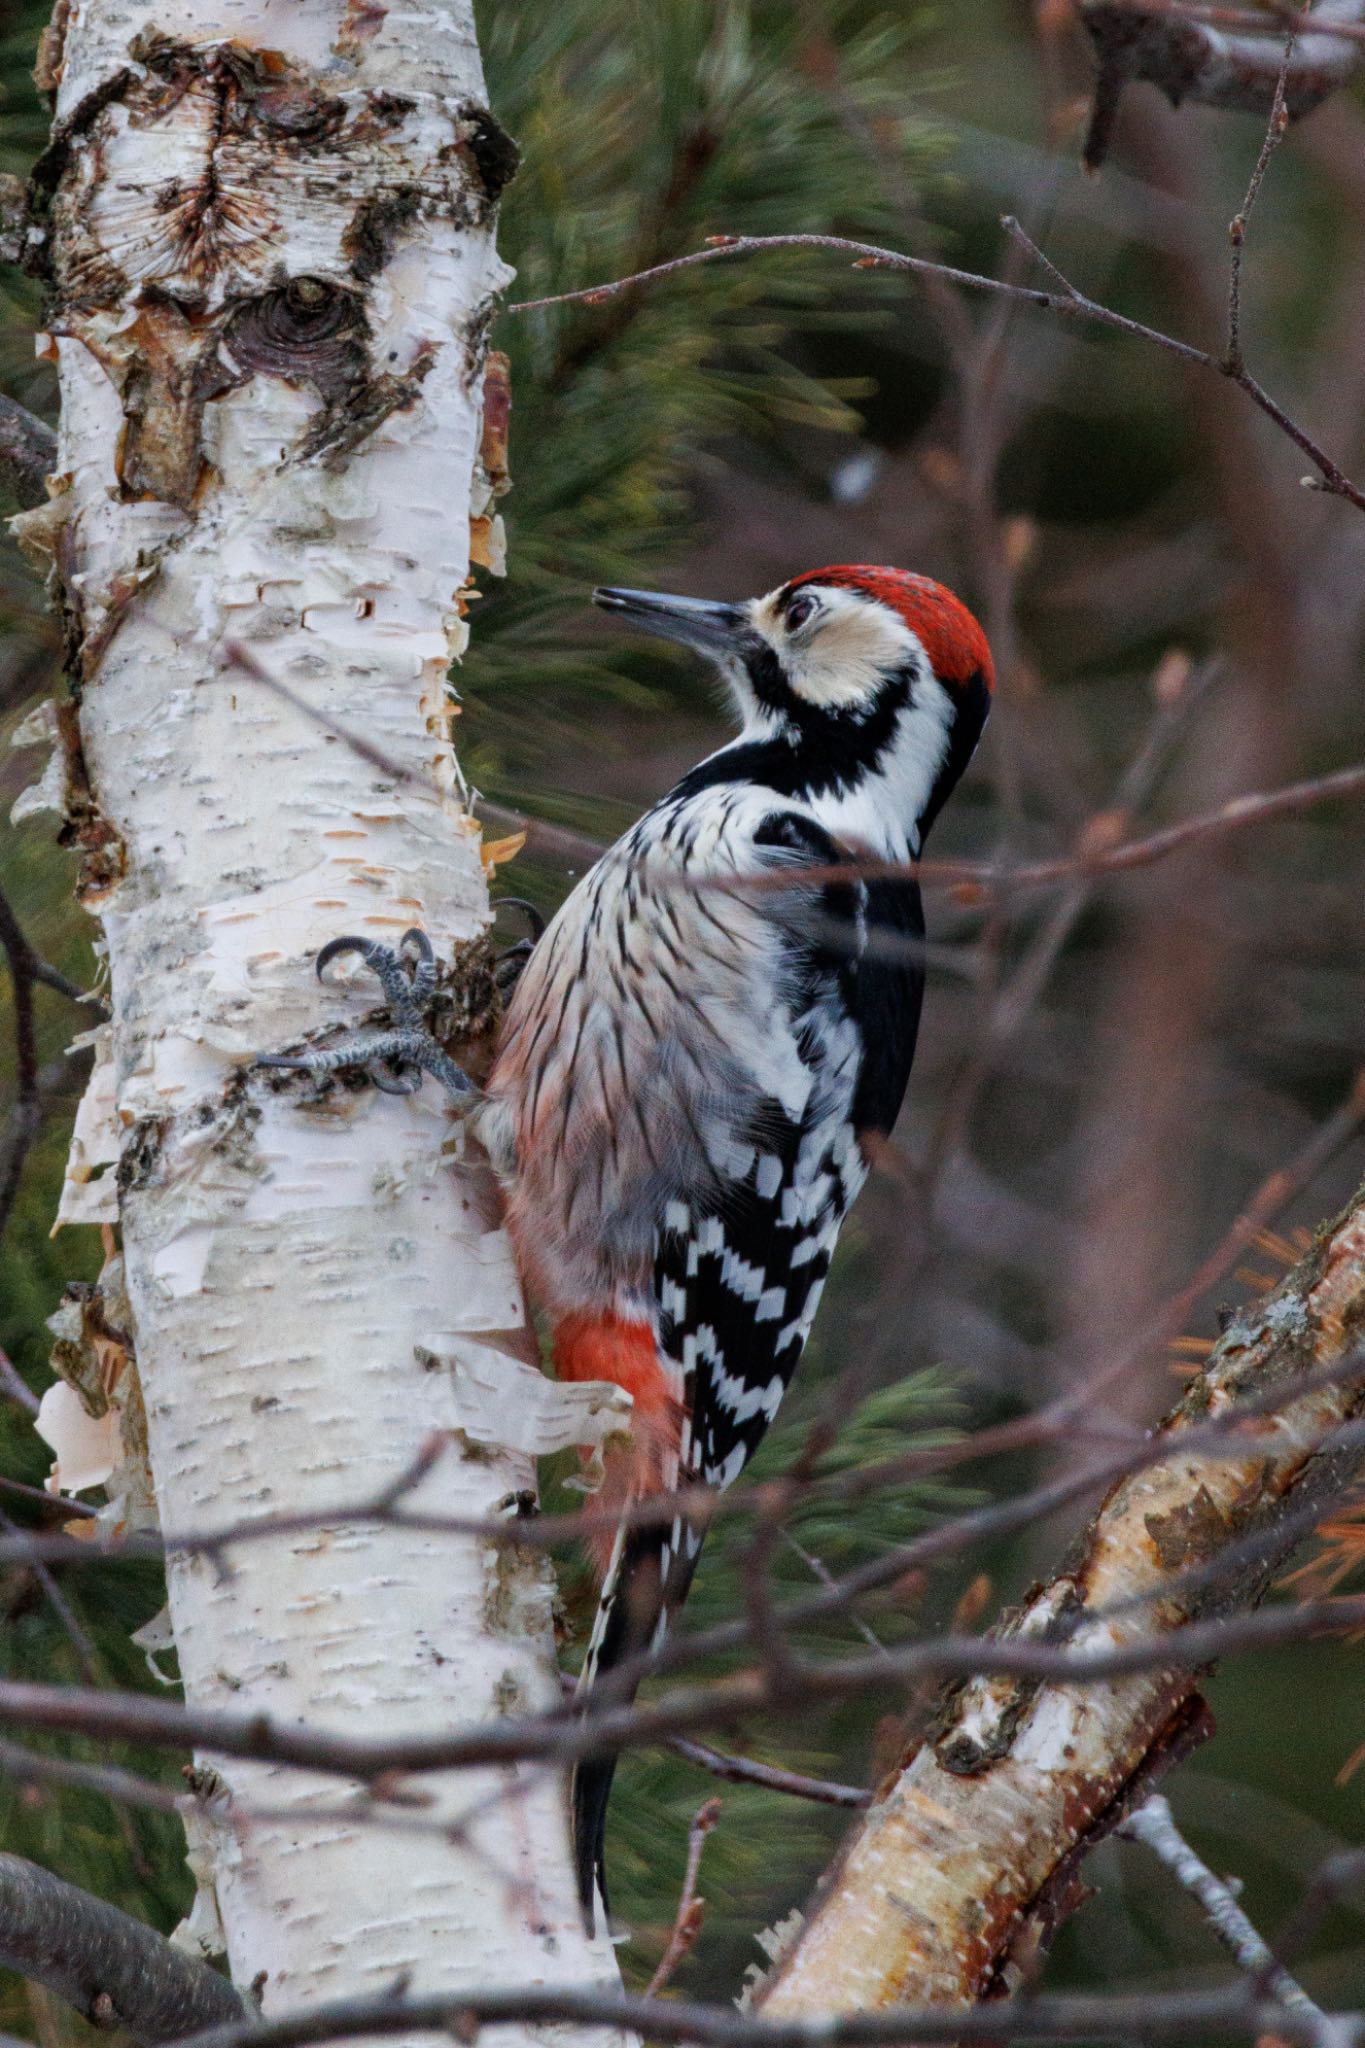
[268,563,995,1927]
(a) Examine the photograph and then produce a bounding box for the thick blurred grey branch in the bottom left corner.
[0,1855,246,2042]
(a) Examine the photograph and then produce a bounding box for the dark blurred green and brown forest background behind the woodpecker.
[0,0,1365,2023]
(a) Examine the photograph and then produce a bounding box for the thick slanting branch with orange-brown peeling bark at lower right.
[757,1190,1365,2019]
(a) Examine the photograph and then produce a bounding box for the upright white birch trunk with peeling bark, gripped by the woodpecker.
[29,0,616,2032]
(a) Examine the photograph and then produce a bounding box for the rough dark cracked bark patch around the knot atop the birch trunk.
[33,29,516,510]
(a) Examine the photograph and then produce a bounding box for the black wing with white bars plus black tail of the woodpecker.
[573,811,923,1925]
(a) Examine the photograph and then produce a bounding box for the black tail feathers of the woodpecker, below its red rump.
[571,1528,700,1933]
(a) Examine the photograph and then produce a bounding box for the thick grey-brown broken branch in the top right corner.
[1074,0,1365,170]
